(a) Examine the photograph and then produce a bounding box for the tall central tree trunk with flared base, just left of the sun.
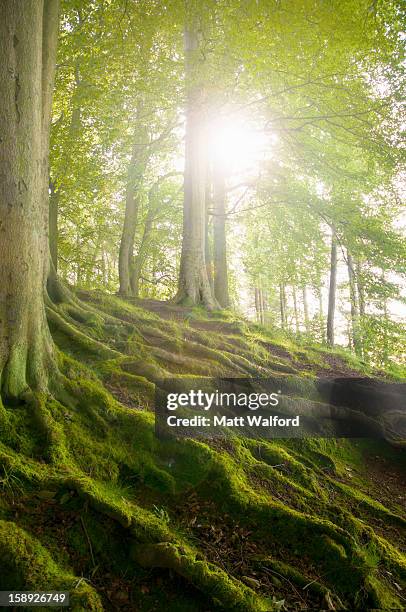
[175,7,218,308]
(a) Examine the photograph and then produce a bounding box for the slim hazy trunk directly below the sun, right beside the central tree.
[213,168,230,308]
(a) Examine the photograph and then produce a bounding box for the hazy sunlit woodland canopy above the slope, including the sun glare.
[46,0,405,372]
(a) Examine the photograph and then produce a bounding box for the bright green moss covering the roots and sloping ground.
[0,294,405,610]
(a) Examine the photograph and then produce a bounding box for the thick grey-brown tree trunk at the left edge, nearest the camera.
[0,0,58,397]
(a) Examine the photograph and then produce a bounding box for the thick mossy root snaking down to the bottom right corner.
[206,455,402,607]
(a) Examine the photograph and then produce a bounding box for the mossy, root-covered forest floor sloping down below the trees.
[0,292,406,612]
